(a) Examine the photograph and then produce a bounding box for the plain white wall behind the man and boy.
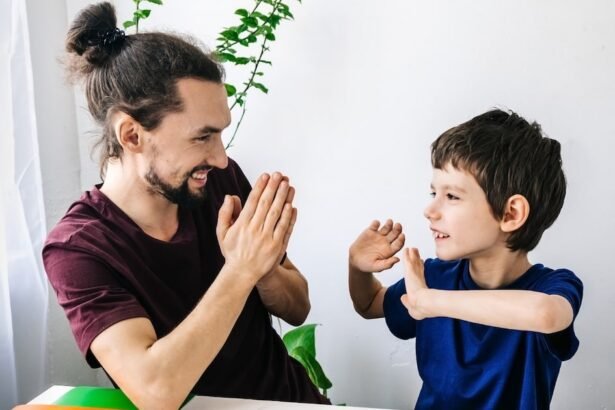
[37,0,615,409]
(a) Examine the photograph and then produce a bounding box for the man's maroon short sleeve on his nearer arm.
[43,246,149,367]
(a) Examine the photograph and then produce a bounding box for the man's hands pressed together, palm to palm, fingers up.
[216,172,297,283]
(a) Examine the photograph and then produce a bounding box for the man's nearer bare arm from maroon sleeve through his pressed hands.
[90,174,296,409]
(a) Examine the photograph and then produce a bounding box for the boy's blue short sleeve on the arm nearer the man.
[382,279,416,339]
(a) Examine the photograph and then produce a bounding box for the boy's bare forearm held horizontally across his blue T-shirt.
[416,289,573,333]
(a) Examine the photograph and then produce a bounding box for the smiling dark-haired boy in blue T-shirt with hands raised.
[349,110,583,409]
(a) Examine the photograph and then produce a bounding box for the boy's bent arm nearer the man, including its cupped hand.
[348,219,405,319]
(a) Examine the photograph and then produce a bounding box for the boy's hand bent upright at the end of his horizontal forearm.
[401,248,429,320]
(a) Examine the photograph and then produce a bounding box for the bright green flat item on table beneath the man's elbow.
[54,386,194,410]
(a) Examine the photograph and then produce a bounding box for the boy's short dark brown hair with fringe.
[431,109,566,252]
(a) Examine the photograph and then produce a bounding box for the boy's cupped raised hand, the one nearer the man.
[349,219,406,272]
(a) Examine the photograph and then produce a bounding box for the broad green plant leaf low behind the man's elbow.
[282,324,332,397]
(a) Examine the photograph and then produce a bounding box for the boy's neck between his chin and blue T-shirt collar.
[470,250,532,289]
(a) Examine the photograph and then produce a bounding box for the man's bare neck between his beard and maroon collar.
[100,161,179,241]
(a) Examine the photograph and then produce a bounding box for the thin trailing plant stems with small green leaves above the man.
[124,0,301,149]
